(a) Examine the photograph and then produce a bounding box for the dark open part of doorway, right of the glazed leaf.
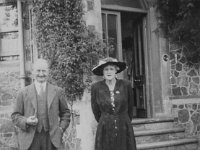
[121,12,147,118]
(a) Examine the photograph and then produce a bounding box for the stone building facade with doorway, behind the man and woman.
[0,0,200,150]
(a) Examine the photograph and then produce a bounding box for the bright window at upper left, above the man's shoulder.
[0,5,19,60]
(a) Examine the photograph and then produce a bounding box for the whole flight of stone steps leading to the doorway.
[132,118,198,150]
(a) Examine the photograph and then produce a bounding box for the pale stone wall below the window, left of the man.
[0,60,20,150]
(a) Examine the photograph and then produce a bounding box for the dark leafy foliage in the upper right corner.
[157,0,200,62]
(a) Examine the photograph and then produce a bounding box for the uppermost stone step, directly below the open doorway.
[132,117,174,131]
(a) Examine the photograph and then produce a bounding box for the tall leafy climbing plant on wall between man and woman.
[33,0,105,100]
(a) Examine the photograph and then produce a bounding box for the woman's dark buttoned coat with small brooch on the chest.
[91,79,136,150]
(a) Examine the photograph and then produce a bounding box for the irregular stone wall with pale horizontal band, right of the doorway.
[169,43,200,136]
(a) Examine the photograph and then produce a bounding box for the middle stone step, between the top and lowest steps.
[135,128,185,144]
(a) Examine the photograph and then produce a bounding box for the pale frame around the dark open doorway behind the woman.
[101,5,155,118]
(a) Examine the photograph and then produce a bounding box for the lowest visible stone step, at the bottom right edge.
[137,138,198,150]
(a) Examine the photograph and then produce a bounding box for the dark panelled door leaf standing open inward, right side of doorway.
[132,18,147,118]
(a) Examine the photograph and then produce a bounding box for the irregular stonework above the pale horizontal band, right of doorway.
[170,44,200,99]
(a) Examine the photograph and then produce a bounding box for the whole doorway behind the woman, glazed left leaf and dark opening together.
[102,10,148,118]
